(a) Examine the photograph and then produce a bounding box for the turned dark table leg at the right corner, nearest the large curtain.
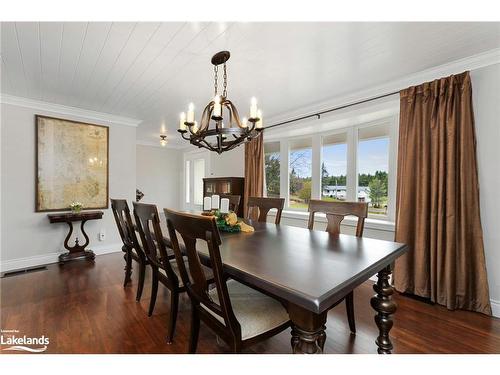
[370,266,397,354]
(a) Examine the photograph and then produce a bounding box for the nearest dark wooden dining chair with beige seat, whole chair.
[164,209,290,353]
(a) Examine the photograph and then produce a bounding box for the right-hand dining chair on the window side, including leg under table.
[307,199,368,333]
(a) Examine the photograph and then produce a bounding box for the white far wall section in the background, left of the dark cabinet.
[136,145,182,210]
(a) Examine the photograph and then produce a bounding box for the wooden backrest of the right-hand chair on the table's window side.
[307,199,368,237]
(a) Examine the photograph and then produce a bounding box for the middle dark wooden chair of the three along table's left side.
[133,202,213,344]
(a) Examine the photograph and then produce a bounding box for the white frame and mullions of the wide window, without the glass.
[264,113,399,223]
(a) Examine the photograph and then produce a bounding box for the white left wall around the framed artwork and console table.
[0,104,136,270]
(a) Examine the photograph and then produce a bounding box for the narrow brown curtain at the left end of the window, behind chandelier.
[243,133,264,220]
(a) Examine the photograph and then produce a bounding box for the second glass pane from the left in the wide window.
[288,138,312,210]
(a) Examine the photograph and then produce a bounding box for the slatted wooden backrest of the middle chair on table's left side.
[133,202,179,287]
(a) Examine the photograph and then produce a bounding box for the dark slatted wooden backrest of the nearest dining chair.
[164,208,241,334]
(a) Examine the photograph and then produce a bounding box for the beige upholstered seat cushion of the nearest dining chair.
[201,280,289,340]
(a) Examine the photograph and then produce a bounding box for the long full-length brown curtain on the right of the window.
[394,72,491,315]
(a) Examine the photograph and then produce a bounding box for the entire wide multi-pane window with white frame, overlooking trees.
[264,114,398,221]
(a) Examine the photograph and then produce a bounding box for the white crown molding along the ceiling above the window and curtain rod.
[266,48,500,125]
